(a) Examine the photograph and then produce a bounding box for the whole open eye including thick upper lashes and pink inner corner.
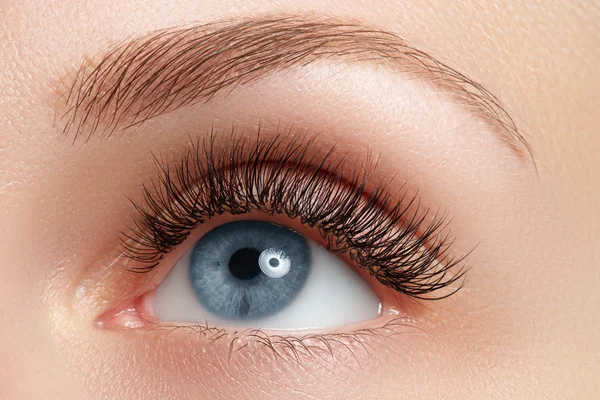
[109,135,466,330]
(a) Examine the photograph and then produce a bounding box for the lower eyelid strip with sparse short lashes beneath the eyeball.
[98,304,424,367]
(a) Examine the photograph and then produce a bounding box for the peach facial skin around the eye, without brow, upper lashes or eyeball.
[0,0,600,400]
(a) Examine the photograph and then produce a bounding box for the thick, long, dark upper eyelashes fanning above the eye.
[122,128,467,300]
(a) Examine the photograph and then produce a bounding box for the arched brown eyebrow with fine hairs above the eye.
[60,17,531,155]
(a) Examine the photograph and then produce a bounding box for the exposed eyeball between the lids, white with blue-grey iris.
[154,220,381,330]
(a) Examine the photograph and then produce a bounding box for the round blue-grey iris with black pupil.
[189,221,311,320]
